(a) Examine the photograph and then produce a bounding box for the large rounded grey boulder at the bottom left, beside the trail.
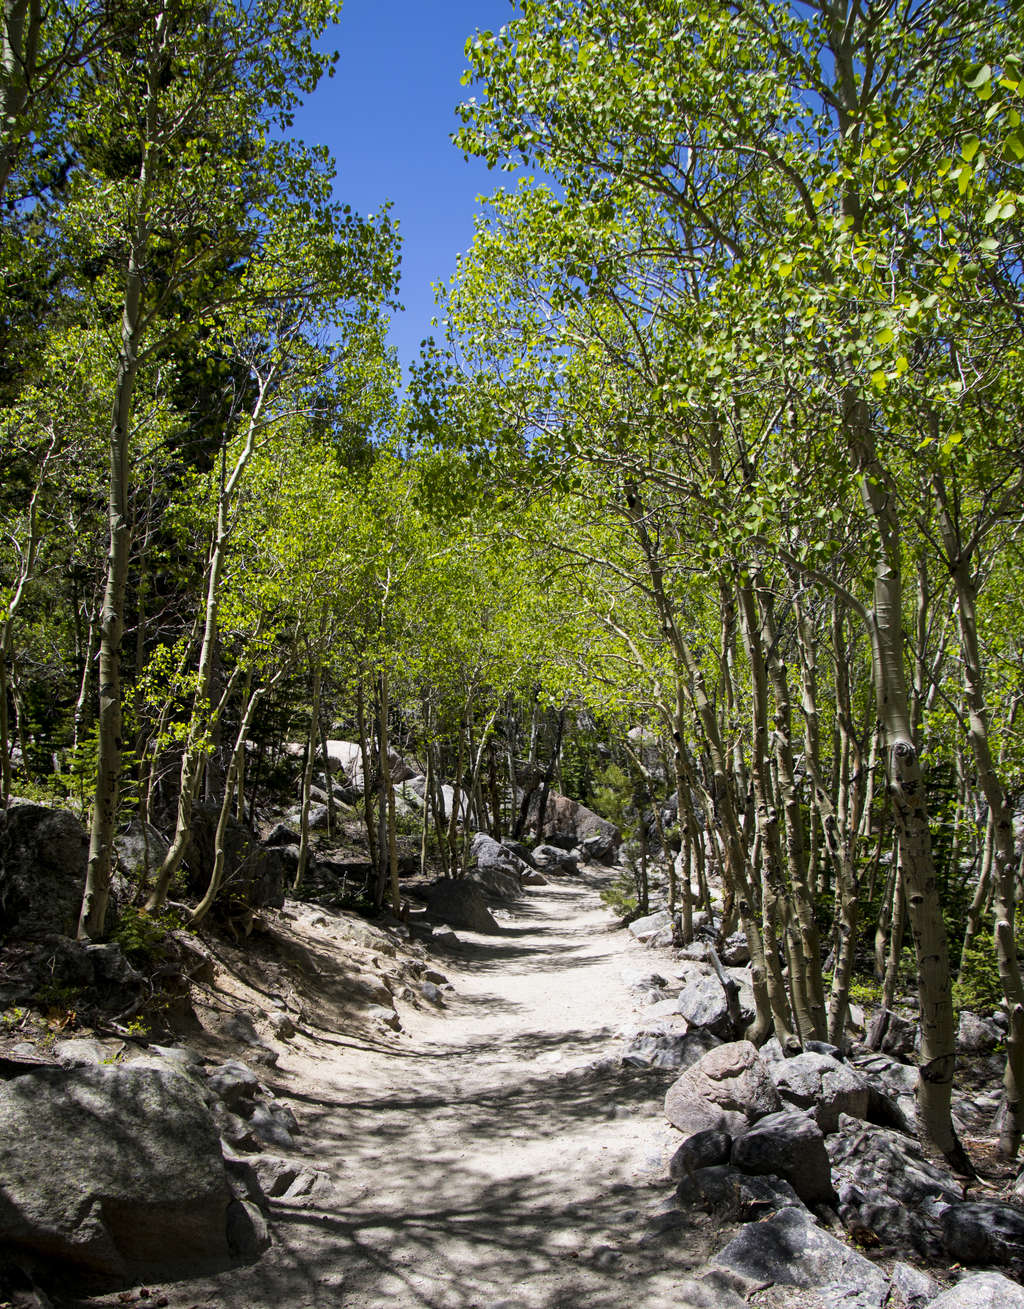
[0,1064,232,1280]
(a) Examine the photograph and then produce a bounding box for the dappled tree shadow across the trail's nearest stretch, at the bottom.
[174,1168,714,1309]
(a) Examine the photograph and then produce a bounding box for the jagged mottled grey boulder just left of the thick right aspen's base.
[826,1117,962,1258]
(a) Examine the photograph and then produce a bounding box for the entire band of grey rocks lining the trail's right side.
[622,937,1024,1309]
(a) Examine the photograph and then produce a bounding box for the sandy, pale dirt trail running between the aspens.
[169,880,728,1309]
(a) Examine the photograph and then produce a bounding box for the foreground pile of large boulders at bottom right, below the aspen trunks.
[665,1041,1024,1309]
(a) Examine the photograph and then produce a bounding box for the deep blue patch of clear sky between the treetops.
[295,0,515,382]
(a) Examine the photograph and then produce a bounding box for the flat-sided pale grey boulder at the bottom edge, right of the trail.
[712,1206,889,1309]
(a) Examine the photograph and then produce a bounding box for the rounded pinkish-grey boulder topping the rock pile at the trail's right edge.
[665,1041,782,1136]
